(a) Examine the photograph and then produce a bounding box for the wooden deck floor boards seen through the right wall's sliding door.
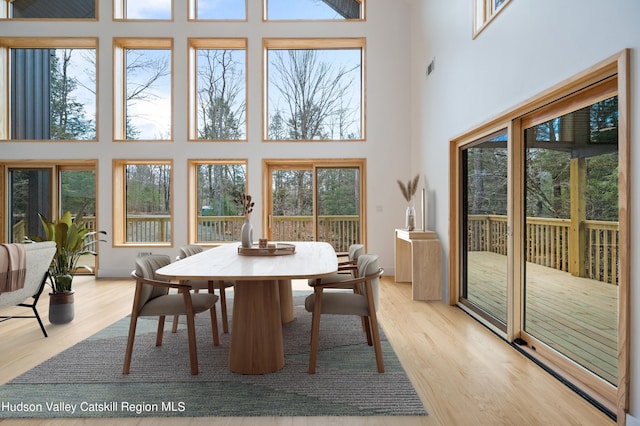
[468,251,618,384]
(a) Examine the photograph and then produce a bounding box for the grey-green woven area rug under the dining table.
[0,295,427,418]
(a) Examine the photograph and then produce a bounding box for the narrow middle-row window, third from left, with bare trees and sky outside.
[189,39,247,141]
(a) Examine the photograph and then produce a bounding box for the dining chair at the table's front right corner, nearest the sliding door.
[304,254,384,374]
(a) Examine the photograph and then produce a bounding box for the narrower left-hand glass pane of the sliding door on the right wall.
[460,130,508,331]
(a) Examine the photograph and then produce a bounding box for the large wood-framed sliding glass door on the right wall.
[449,60,631,414]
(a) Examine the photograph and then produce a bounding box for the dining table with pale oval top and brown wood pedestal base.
[156,241,338,374]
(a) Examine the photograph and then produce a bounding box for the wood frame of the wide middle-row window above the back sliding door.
[262,37,367,143]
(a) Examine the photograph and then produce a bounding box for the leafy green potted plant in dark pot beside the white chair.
[29,211,106,324]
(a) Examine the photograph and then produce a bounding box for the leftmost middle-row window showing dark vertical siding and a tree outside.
[0,37,98,141]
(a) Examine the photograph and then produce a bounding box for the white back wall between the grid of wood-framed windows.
[0,0,411,277]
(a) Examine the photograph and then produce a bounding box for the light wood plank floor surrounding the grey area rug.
[0,277,614,426]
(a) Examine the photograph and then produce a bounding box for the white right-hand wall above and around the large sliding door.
[407,0,640,424]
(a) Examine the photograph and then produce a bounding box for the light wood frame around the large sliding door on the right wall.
[448,49,631,424]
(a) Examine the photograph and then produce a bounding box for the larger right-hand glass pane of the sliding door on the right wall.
[523,96,618,384]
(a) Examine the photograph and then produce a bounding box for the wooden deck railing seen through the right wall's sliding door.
[467,215,619,284]
